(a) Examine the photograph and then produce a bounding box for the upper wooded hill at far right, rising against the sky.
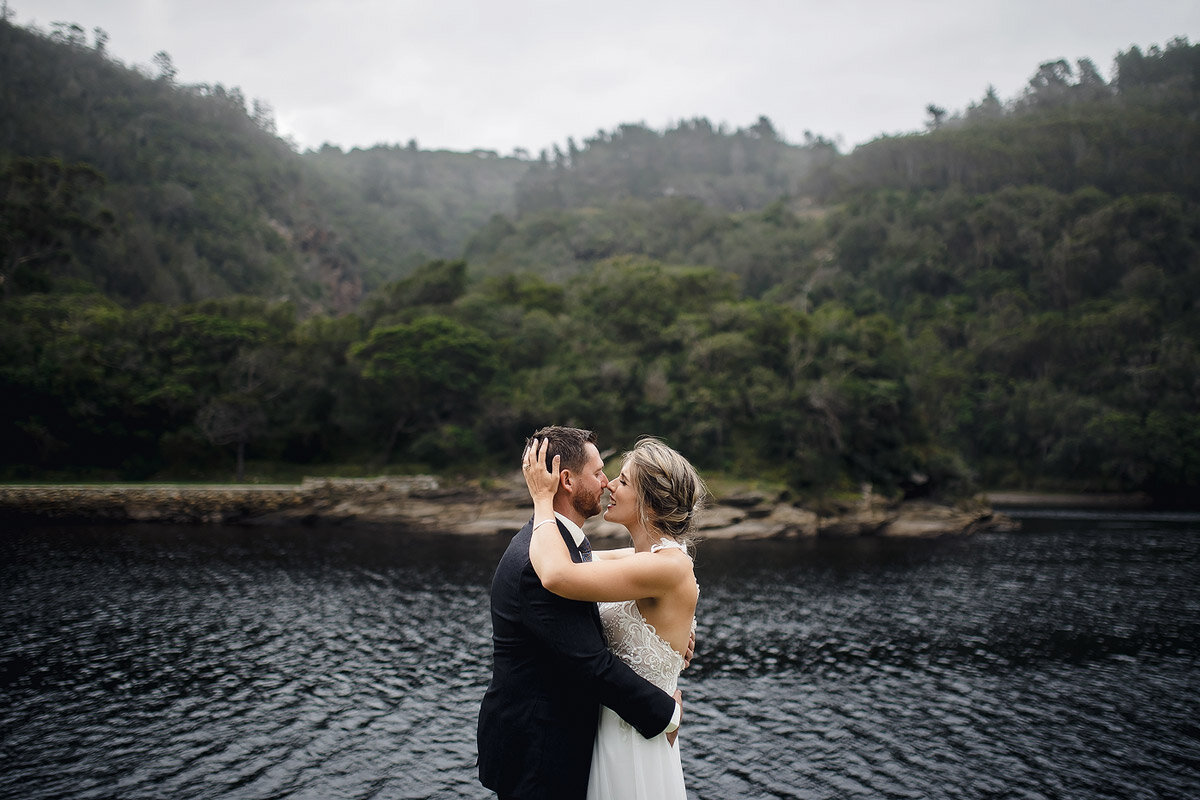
[838,49,1200,200]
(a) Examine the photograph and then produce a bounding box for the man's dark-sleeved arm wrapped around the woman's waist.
[522,569,680,739]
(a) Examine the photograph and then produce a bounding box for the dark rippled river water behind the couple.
[0,515,1200,800]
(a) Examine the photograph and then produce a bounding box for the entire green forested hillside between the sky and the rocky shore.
[0,18,1200,503]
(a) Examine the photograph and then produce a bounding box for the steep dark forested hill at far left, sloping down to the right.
[0,23,331,302]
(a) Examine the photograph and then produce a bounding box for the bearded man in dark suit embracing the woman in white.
[479,426,680,800]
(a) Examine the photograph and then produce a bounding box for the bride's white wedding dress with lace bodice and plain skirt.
[588,539,696,800]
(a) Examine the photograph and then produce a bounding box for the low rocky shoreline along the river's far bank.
[0,475,1016,539]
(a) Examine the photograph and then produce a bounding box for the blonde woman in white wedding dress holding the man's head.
[522,438,706,800]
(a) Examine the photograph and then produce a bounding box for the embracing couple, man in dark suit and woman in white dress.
[479,426,704,800]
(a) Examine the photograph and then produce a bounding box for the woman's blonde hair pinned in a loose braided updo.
[623,437,708,551]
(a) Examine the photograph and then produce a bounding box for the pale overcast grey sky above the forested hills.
[7,0,1200,155]
